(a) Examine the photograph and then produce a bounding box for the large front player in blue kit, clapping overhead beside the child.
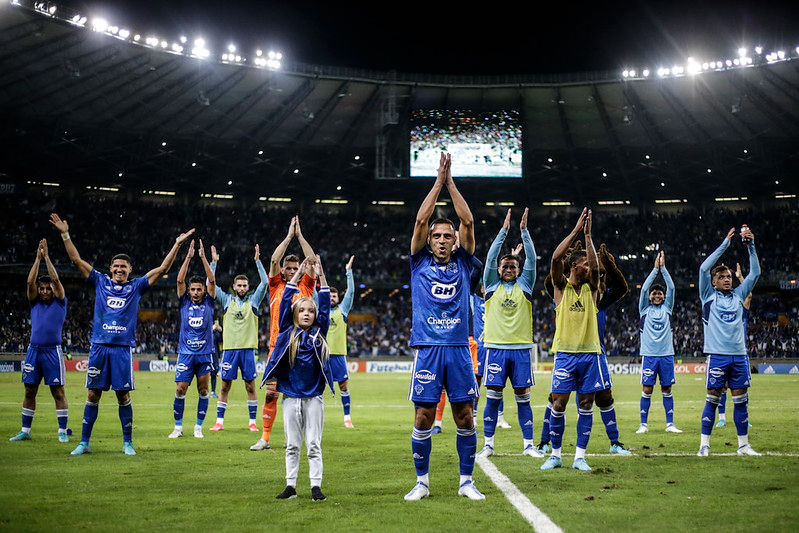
[405,153,485,500]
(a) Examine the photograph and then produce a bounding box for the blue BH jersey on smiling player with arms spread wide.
[86,269,150,346]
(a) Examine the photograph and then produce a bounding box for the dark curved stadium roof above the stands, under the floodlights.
[0,4,799,203]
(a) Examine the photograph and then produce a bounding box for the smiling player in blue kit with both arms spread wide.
[50,213,194,455]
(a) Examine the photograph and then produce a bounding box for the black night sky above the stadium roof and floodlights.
[58,0,799,74]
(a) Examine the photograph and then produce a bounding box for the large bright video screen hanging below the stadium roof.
[410,109,522,178]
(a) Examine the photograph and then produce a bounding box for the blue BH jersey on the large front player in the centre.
[410,247,474,347]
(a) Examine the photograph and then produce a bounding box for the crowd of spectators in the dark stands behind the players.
[0,187,799,358]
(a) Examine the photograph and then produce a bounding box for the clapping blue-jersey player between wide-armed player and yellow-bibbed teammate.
[169,240,216,439]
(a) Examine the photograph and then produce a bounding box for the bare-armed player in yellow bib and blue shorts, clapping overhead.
[541,208,607,471]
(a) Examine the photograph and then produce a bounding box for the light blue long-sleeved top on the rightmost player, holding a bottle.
[699,239,760,355]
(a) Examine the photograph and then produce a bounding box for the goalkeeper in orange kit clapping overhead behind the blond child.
[250,217,316,451]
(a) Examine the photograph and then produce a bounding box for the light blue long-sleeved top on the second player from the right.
[638,267,674,356]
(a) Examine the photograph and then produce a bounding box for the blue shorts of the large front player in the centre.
[408,346,478,404]
